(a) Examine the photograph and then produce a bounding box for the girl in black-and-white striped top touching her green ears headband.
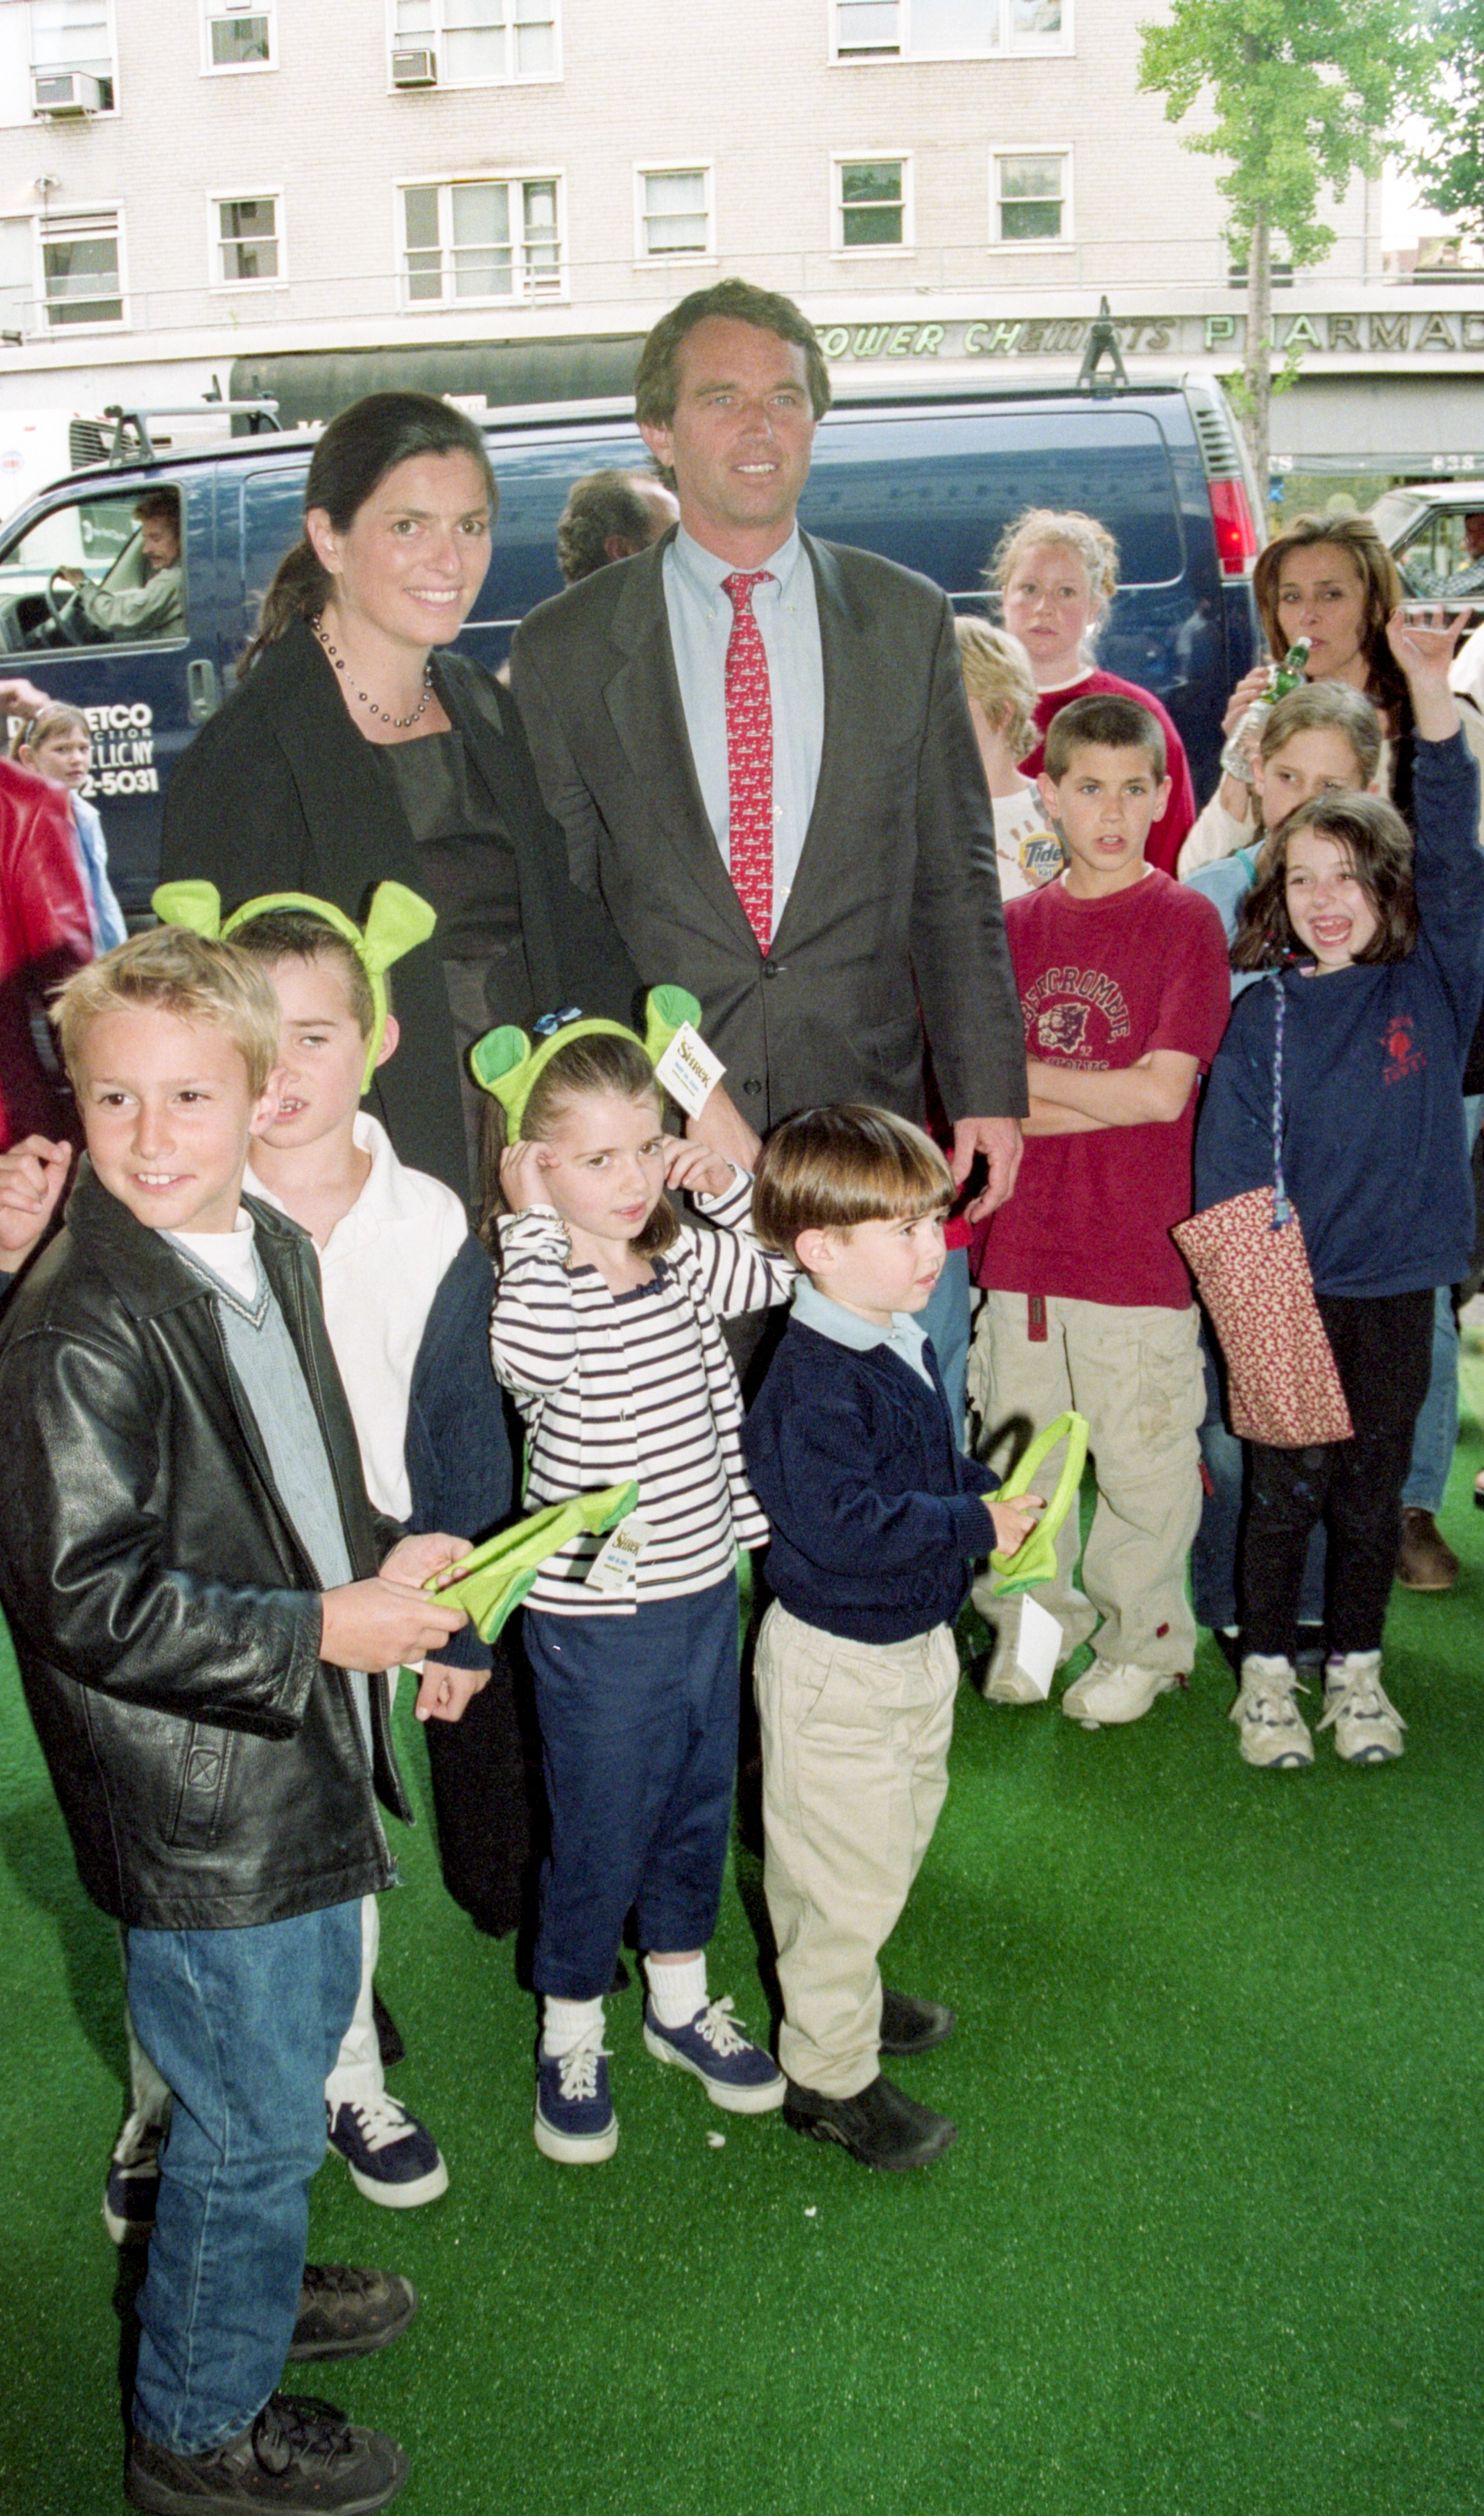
[485,1024,792,2164]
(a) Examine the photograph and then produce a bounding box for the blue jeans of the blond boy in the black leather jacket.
[128,1897,360,2456]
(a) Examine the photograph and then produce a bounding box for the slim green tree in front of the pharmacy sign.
[1139,0,1424,516]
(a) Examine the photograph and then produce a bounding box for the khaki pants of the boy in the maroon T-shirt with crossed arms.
[968,1293,1205,1676]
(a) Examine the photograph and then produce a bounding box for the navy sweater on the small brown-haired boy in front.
[742,1318,996,1643]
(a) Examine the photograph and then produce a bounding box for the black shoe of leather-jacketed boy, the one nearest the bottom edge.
[123,2393,407,2516]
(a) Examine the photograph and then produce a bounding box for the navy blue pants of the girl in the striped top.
[526,1572,739,2000]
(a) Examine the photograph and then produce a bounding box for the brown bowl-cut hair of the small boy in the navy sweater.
[752,1102,953,1258]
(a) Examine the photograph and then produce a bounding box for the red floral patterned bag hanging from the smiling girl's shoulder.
[1170,979,1356,1449]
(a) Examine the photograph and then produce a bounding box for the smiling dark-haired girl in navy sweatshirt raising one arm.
[1195,611,1484,1766]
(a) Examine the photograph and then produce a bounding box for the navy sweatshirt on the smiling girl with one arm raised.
[1195,735,1484,1296]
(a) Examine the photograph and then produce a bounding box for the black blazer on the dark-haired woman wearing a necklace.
[163,621,639,1198]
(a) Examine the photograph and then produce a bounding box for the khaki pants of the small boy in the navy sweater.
[755,1603,958,2096]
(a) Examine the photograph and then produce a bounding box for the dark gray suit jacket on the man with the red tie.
[511,536,1026,1135]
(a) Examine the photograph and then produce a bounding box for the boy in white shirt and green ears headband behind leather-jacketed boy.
[108,883,528,2234]
